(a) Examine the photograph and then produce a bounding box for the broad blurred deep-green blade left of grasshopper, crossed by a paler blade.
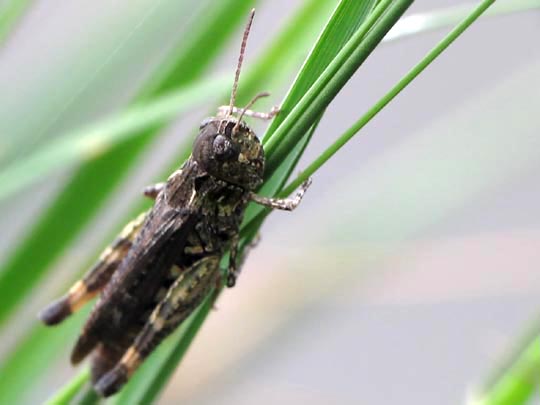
[0,0,253,324]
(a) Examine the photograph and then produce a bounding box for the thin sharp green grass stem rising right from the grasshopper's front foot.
[284,0,495,193]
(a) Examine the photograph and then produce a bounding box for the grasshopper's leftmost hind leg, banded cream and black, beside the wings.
[39,213,146,325]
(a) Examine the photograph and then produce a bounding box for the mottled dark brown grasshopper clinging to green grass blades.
[40,10,309,396]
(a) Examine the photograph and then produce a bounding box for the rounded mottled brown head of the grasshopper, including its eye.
[193,117,264,190]
